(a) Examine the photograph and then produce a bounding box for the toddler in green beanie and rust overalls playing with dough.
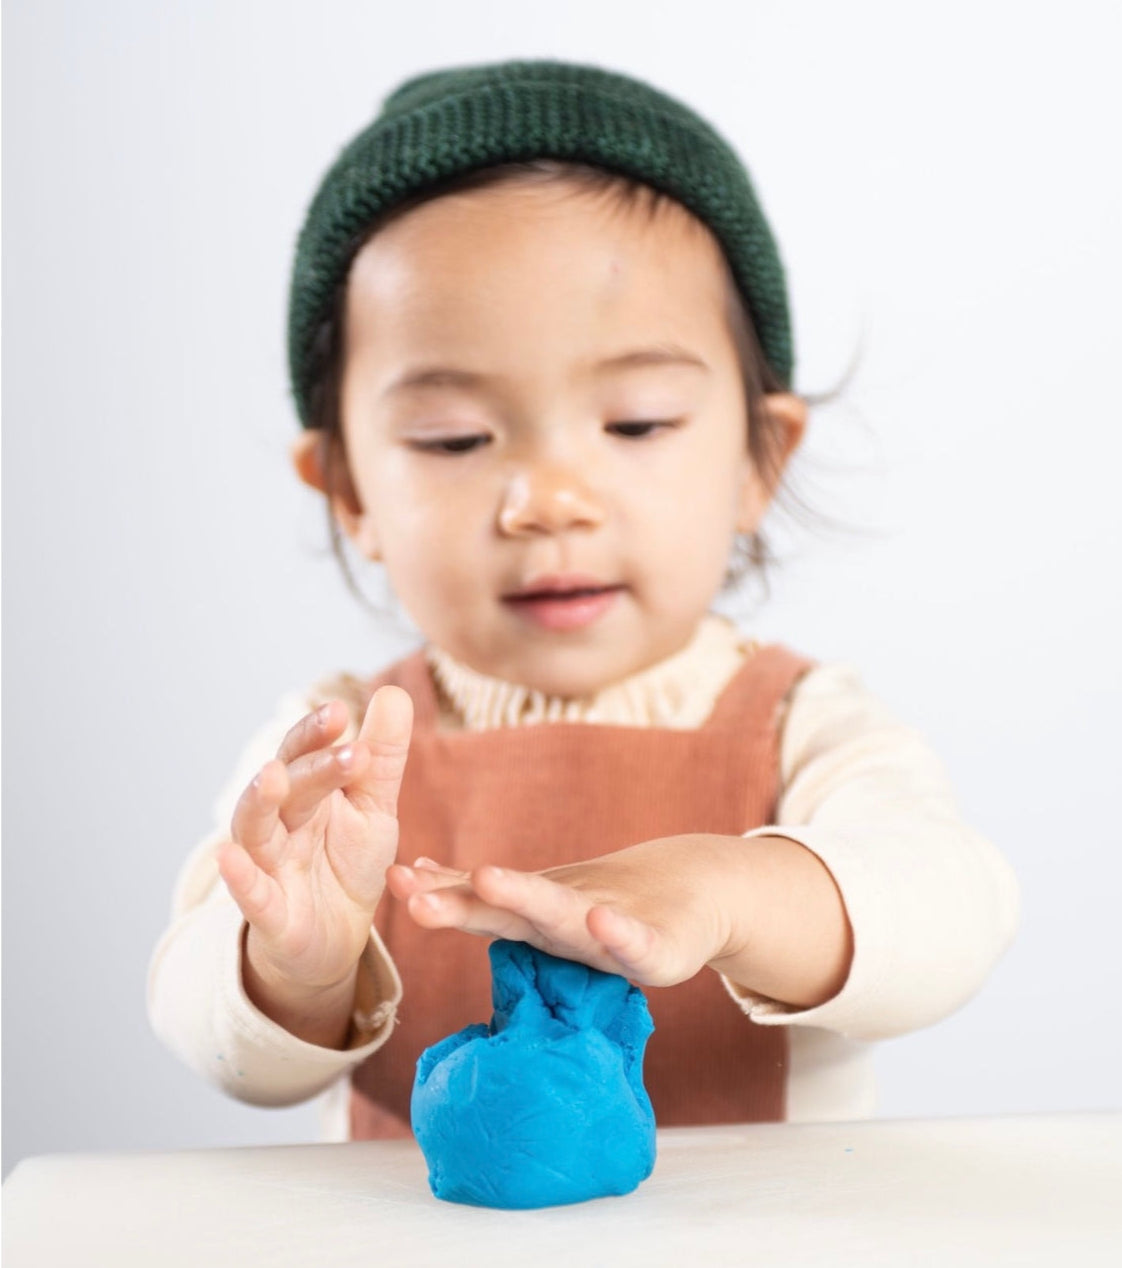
[150,62,1017,1139]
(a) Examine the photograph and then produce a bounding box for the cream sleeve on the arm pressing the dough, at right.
[725,666,1019,1040]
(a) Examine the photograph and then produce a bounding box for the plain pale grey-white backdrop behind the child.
[4,0,1122,1168]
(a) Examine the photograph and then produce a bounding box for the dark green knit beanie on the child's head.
[288,61,794,426]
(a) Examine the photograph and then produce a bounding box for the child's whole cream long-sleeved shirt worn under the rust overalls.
[148,616,1018,1139]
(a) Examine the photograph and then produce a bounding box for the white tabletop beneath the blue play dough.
[4,1113,1122,1268]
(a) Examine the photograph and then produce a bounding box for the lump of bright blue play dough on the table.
[411,942,654,1208]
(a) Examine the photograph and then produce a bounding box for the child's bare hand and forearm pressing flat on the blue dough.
[387,834,852,1006]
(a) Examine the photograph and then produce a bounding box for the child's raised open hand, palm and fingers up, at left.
[217,686,413,1042]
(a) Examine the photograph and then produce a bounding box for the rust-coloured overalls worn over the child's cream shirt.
[339,647,810,1140]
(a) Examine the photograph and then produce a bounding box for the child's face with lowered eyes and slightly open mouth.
[301,185,801,695]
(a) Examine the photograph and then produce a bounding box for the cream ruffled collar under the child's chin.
[425,614,754,730]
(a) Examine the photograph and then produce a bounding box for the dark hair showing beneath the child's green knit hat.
[300,159,786,602]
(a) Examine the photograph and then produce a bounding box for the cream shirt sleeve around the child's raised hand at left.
[148,694,402,1106]
